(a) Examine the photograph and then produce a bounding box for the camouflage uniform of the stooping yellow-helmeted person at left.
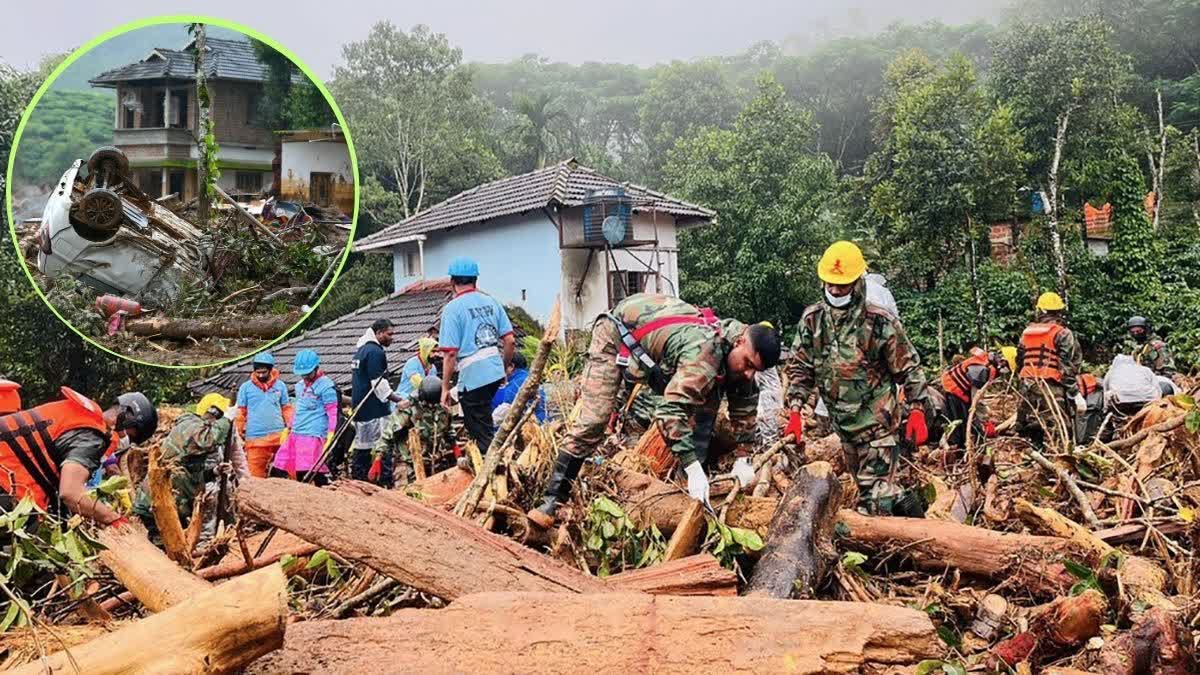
[133,412,233,522]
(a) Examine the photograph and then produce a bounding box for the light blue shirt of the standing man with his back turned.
[438,291,512,392]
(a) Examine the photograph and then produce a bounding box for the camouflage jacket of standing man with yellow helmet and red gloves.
[785,280,929,442]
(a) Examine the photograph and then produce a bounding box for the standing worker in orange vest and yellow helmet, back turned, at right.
[1016,293,1087,448]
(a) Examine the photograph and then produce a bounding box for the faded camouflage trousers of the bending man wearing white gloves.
[563,319,623,458]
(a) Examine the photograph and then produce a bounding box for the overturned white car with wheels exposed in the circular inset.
[37,147,212,304]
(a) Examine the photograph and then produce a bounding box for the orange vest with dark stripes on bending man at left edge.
[0,387,118,509]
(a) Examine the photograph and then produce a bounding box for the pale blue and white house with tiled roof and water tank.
[355,159,716,330]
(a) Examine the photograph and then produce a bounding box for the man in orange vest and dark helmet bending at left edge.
[0,387,158,525]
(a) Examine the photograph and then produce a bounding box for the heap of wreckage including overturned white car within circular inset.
[18,147,350,364]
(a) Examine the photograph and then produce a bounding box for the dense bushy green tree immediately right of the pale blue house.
[664,76,840,325]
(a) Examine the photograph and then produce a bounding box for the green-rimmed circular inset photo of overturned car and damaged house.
[6,17,358,368]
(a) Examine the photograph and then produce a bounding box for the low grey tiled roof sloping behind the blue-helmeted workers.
[187,277,451,396]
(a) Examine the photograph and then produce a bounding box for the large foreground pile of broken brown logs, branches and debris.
[4,312,1200,674]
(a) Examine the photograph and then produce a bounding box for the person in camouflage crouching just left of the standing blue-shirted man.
[372,375,455,483]
